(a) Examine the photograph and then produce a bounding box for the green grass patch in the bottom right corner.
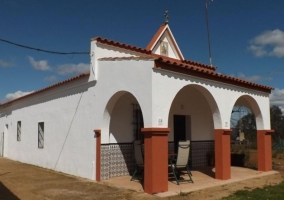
[223,182,284,200]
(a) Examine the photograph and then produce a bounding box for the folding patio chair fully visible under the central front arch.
[170,140,193,185]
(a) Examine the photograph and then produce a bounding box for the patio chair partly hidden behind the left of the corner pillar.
[130,140,144,182]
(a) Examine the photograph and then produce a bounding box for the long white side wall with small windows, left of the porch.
[0,78,95,179]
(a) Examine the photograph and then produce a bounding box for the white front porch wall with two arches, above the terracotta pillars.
[152,69,270,130]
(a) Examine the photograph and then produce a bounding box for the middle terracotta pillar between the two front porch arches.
[214,129,232,180]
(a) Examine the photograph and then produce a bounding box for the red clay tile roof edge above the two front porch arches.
[155,57,274,93]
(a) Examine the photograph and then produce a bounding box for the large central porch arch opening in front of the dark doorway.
[168,84,222,167]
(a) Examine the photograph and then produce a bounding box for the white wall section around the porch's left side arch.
[95,60,154,143]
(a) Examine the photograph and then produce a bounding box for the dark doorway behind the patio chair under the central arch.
[174,115,186,153]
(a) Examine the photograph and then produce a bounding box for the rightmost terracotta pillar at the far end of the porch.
[257,130,274,172]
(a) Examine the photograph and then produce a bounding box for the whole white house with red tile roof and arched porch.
[0,24,273,194]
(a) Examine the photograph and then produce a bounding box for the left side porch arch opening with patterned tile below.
[97,91,143,180]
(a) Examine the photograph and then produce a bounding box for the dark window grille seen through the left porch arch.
[132,104,144,141]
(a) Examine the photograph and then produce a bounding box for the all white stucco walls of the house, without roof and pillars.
[0,37,270,183]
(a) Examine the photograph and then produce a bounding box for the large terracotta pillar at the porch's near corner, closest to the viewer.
[142,128,170,194]
